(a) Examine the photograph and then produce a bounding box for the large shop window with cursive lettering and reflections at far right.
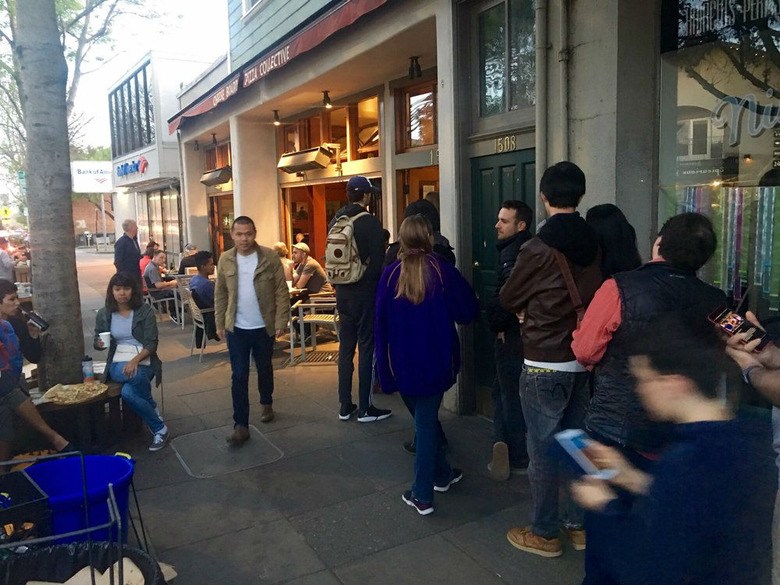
[659,0,780,317]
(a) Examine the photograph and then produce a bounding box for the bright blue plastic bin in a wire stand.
[27,455,134,544]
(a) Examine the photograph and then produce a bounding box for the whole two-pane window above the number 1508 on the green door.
[477,0,536,116]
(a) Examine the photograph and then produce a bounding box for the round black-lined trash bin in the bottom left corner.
[0,542,165,585]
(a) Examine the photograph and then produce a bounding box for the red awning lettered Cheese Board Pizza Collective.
[168,0,388,134]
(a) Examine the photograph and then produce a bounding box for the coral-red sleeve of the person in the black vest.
[571,278,621,366]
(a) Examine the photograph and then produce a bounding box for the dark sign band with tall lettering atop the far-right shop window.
[661,0,780,52]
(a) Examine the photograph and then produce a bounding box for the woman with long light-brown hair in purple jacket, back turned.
[374,215,478,515]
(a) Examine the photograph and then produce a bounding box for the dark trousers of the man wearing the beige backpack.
[336,292,374,410]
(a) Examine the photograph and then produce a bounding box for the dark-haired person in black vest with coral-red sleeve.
[572,213,726,460]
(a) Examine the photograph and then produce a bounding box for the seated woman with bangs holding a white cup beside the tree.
[94,272,168,451]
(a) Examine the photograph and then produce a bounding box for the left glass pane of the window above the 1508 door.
[479,2,506,116]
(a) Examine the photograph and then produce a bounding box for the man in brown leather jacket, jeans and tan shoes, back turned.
[499,162,601,557]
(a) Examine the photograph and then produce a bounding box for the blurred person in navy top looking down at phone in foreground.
[572,314,777,585]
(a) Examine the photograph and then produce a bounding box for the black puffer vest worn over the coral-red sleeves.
[585,262,726,452]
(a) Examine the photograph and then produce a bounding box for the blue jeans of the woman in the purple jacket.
[401,394,452,503]
